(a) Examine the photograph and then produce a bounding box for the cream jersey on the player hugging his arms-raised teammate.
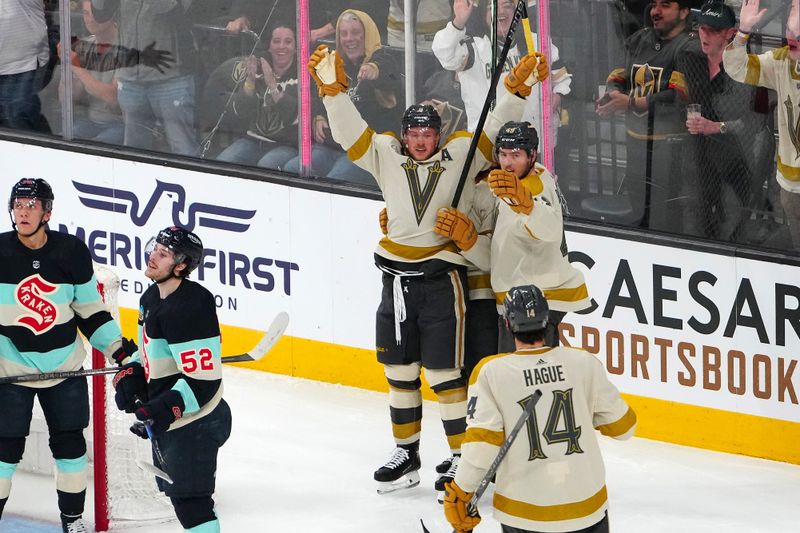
[463,163,591,312]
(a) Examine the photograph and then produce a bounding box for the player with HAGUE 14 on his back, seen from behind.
[444,285,636,533]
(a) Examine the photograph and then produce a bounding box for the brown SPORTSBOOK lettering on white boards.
[560,322,798,405]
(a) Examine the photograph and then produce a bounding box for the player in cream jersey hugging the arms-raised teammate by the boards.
[436,121,591,351]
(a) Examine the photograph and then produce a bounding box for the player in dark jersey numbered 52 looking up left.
[114,226,231,533]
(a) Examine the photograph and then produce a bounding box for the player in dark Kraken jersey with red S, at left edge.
[0,179,133,533]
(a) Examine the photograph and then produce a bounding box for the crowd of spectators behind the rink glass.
[0,0,800,254]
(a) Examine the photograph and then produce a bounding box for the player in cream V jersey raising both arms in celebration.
[308,42,547,493]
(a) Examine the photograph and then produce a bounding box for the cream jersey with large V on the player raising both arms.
[323,88,525,265]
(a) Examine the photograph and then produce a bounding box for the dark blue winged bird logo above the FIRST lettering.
[72,180,256,233]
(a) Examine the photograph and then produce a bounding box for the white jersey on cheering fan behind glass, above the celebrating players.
[432,22,572,133]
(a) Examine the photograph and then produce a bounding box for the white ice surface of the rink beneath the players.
[0,368,800,533]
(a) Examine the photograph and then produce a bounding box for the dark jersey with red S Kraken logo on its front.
[0,231,120,387]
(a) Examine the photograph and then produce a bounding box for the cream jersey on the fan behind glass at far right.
[722,40,800,193]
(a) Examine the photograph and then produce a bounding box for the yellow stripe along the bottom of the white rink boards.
[120,308,800,465]
